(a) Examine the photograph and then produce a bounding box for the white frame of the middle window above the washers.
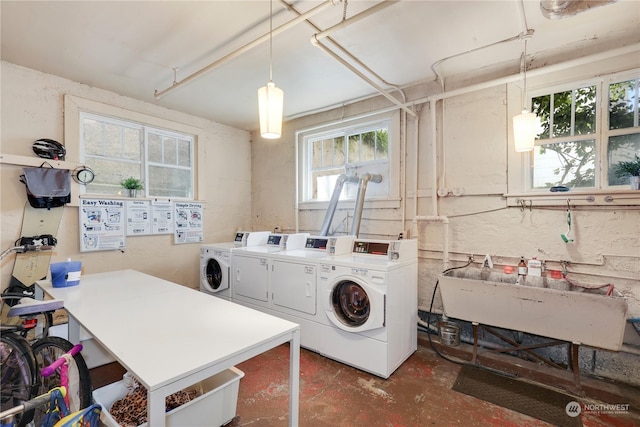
[296,110,401,210]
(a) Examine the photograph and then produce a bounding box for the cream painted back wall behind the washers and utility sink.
[252,52,640,383]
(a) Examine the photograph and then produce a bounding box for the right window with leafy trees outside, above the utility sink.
[530,73,640,190]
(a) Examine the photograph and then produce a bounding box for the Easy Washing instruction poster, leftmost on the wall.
[79,199,125,252]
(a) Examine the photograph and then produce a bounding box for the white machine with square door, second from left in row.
[231,233,309,313]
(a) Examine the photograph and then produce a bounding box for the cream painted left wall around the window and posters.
[0,61,251,288]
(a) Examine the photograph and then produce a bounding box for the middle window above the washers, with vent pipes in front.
[298,114,398,206]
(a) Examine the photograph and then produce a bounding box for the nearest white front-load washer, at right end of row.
[318,239,418,378]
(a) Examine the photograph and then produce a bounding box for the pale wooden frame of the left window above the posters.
[64,95,204,201]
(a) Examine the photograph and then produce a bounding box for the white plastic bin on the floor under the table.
[93,367,244,427]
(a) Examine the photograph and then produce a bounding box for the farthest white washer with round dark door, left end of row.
[200,231,269,300]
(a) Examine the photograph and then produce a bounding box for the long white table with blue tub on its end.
[37,270,300,427]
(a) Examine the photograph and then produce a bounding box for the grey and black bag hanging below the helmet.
[20,162,71,209]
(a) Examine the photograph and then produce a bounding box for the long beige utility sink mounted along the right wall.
[439,269,627,350]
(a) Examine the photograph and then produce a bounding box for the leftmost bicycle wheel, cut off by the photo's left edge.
[0,332,36,425]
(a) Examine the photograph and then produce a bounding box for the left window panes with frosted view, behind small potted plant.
[80,112,194,198]
